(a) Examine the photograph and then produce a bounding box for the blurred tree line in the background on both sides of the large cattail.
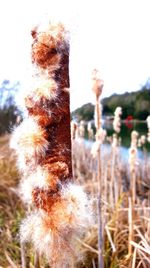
[0,80,150,135]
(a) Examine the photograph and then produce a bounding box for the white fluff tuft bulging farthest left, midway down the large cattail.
[10,117,48,171]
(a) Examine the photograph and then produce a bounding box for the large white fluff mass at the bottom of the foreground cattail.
[21,183,92,267]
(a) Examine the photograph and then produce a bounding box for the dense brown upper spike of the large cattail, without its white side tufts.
[28,23,72,179]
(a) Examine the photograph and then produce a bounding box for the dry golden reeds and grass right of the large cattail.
[73,140,150,268]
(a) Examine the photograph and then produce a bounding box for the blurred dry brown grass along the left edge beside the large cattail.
[0,135,24,268]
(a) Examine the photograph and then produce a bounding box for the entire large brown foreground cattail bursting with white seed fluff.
[12,20,90,268]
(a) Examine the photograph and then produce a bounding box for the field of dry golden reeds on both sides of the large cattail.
[0,123,150,268]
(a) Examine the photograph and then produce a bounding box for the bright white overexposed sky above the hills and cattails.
[0,0,150,109]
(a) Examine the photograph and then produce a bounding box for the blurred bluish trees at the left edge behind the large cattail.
[0,80,19,135]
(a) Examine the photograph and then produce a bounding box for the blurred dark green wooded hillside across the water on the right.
[72,81,150,121]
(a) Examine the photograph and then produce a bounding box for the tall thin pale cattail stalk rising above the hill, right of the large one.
[92,70,104,268]
